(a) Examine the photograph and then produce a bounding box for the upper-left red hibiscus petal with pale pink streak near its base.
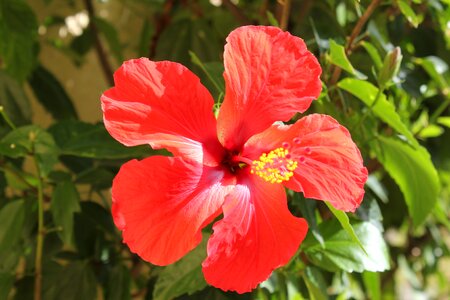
[101,58,222,164]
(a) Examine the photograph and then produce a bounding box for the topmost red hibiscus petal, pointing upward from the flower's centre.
[218,26,322,150]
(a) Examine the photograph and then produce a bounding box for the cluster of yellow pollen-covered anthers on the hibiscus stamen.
[250,147,298,183]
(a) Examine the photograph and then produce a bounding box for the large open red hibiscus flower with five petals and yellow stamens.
[101,26,367,293]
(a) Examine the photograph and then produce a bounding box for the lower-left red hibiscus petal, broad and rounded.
[112,156,234,265]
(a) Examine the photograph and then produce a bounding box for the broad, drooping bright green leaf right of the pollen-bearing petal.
[372,136,440,226]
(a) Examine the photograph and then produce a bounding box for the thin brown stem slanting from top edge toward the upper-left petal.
[84,0,114,86]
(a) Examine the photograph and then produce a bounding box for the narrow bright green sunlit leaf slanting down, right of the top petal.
[338,78,419,147]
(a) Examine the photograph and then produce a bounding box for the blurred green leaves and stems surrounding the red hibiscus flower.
[0,0,450,300]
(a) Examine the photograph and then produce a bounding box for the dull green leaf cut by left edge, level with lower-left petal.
[0,200,25,261]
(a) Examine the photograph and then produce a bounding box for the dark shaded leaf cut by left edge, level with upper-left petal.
[0,70,31,131]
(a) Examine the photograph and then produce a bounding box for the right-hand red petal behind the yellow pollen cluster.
[242,114,367,211]
